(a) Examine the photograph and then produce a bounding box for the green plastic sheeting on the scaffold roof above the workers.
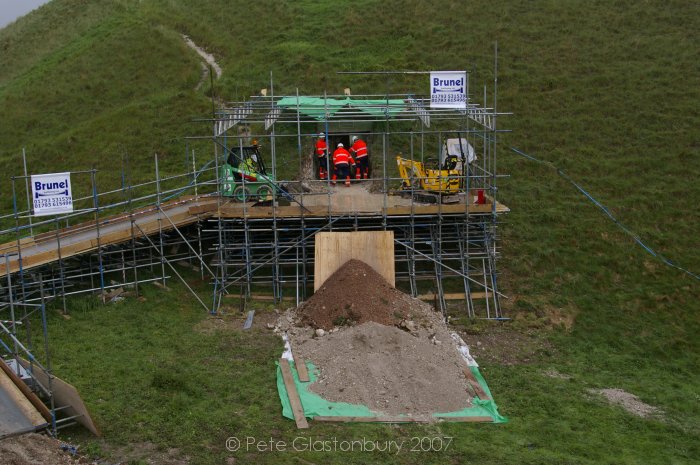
[276,97,407,121]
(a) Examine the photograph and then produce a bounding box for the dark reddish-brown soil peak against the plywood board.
[296,260,425,330]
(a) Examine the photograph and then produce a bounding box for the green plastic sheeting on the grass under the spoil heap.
[277,362,508,423]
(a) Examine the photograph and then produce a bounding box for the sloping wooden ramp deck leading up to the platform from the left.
[0,196,218,276]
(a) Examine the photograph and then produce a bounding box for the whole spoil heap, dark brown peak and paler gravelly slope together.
[282,260,472,417]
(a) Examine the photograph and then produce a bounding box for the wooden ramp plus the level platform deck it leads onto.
[0,185,509,277]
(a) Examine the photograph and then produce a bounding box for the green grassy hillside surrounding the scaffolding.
[0,0,700,464]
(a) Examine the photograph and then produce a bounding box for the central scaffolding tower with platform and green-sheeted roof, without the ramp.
[201,85,507,319]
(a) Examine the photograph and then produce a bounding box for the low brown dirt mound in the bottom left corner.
[0,433,78,465]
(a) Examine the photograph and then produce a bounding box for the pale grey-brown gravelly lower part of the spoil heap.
[292,322,470,416]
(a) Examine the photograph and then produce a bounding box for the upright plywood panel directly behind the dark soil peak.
[314,231,396,291]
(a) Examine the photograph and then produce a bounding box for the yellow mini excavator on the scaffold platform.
[396,137,476,203]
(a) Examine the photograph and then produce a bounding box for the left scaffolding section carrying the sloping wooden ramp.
[0,158,216,435]
